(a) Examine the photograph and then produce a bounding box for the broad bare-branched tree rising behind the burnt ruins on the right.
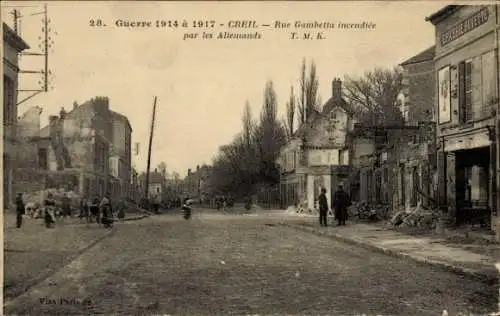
[344,67,404,126]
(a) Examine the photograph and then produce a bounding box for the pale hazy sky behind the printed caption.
[2,1,449,176]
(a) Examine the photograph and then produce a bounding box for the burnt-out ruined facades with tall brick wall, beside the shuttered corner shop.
[348,47,436,217]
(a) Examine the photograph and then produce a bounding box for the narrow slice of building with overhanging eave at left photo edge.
[2,23,30,207]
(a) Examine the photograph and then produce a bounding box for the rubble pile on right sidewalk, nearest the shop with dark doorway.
[389,203,439,229]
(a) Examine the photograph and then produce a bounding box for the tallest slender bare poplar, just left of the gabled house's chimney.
[297,59,321,124]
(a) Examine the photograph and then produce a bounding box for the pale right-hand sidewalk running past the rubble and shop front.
[281,215,500,282]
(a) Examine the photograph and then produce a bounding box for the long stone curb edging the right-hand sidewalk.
[279,223,498,282]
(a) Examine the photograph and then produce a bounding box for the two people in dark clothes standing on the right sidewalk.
[318,185,351,227]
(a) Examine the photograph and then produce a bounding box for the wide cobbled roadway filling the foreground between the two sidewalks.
[4,214,497,315]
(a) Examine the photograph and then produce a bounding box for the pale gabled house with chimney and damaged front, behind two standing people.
[277,79,353,210]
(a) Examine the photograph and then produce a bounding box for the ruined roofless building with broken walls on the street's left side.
[16,97,132,198]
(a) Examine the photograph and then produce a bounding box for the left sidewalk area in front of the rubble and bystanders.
[3,213,113,300]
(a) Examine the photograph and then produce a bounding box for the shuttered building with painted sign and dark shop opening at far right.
[426,5,500,232]
